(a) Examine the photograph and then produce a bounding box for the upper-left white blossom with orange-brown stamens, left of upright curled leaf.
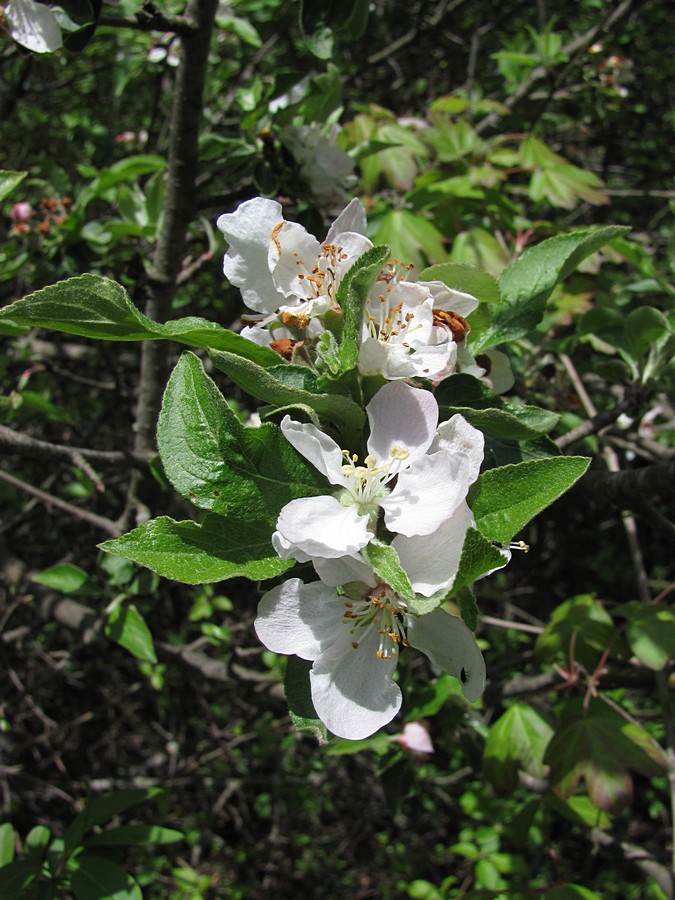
[217,197,372,343]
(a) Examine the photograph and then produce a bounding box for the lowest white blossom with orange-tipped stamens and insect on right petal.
[255,578,485,740]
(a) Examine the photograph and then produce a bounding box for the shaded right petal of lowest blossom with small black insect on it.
[408,609,485,703]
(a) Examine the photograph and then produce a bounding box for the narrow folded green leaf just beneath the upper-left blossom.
[209,348,365,446]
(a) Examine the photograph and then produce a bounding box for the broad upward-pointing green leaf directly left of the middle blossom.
[157,353,325,524]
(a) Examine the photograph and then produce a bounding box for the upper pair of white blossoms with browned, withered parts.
[218,197,512,390]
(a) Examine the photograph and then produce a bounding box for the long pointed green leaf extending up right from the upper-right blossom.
[471,225,630,353]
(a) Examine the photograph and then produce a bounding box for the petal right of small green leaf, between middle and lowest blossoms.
[392,503,474,597]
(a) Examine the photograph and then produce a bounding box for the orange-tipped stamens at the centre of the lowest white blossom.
[344,585,408,659]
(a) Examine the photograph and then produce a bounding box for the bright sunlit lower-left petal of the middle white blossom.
[275,496,374,559]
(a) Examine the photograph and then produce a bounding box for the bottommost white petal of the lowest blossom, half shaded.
[310,626,401,741]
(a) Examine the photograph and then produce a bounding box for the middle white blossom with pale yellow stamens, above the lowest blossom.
[272,381,484,564]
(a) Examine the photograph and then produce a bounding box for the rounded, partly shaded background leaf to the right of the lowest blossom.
[535,594,614,671]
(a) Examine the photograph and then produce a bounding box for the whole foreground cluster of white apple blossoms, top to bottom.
[218,198,508,740]
